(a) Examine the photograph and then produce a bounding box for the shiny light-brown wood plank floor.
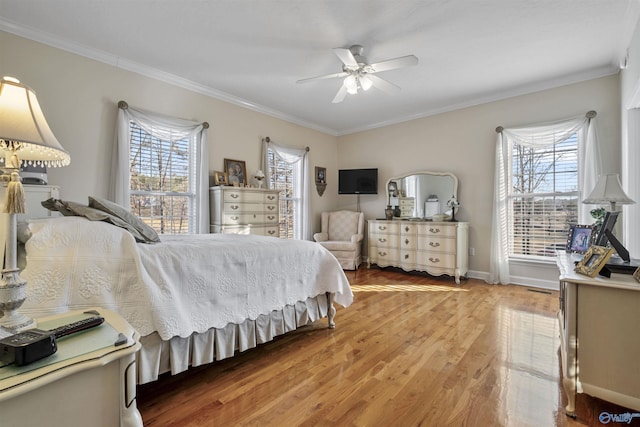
[138,267,633,427]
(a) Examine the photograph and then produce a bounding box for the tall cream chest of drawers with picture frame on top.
[209,187,280,237]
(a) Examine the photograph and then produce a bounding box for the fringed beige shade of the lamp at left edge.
[0,77,71,167]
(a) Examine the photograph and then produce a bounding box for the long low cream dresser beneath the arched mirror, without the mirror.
[368,220,469,284]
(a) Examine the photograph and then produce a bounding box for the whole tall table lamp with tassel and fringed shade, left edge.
[0,77,71,332]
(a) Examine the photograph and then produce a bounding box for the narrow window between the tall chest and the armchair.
[267,148,302,239]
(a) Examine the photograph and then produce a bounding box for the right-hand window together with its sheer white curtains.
[487,111,600,283]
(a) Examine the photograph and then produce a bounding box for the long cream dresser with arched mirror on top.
[368,171,469,284]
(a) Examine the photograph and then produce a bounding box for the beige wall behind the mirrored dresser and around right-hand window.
[338,75,620,273]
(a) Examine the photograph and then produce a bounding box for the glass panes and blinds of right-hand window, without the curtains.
[508,133,580,257]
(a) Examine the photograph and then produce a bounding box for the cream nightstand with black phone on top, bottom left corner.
[0,308,142,427]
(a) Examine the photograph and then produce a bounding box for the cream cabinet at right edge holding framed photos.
[557,252,640,414]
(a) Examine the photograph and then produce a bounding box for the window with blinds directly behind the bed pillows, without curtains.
[129,121,196,234]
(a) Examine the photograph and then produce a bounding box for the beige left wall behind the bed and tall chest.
[0,31,337,236]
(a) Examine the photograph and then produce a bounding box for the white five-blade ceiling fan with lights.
[296,44,418,104]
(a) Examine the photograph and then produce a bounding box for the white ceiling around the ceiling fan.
[0,0,640,135]
